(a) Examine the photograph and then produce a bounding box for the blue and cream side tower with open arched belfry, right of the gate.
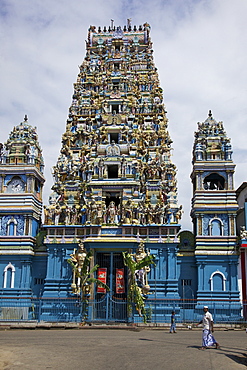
[191,111,239,307]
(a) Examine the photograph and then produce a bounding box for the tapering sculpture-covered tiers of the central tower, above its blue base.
[45,24,181,225]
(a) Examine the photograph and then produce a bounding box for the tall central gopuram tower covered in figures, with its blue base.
[44,21,182,320]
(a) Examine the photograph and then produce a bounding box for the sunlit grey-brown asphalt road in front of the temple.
[0,329,247,370]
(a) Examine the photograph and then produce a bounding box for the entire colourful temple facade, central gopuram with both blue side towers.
[0,20,243,322]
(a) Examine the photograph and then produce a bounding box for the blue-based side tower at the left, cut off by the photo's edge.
[0,116,45,296]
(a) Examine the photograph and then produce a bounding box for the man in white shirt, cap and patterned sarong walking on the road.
[196,306,220,350]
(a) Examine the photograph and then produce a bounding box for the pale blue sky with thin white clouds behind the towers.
[0,0,247,230]
